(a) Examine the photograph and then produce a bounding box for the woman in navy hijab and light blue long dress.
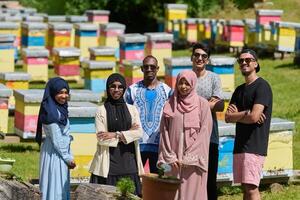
[36,77,76,200]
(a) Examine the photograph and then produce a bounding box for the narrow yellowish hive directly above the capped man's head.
[244,19,256,47]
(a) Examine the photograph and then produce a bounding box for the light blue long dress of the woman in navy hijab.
[40,122,73,200]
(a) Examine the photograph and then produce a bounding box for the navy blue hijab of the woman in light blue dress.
[35,77,70,145]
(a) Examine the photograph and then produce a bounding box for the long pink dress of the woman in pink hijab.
[158,97,212,200]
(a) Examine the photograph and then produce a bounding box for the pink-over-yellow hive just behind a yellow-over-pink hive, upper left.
[47,23,72,52]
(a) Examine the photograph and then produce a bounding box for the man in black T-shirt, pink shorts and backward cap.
[225,49,272,200]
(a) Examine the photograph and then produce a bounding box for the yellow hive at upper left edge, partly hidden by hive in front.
[0,22,21,49]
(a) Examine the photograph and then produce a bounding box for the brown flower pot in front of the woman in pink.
[141,174,181,200]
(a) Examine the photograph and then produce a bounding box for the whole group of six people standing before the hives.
[37,43,272,200]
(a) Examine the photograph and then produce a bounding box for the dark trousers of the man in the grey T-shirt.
[207,143,219,200]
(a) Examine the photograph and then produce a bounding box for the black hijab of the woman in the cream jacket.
[104,73,131,132]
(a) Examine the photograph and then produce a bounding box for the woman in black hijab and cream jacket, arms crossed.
[90,73,144,195]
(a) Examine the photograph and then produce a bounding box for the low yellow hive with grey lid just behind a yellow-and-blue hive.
[89,46,117,62]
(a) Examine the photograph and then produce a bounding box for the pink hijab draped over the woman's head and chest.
[163,70,200,129]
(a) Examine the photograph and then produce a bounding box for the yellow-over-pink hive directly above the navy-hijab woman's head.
[53,47,80,81]
